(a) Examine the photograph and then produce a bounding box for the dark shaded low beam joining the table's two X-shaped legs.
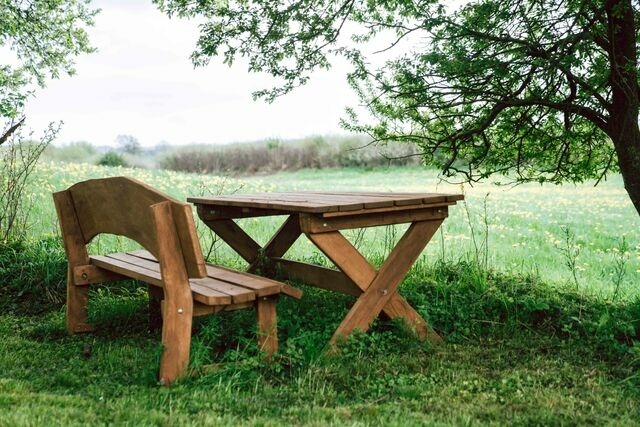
[273,258,362,297]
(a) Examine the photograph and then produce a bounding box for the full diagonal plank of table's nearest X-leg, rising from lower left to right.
[330,220,442,345]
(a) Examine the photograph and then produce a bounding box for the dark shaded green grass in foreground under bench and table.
[0,264,640,425]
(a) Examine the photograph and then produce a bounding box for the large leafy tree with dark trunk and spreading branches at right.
[154,0,640,216]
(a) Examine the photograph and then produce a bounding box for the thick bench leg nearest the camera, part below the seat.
[160,290,193,385]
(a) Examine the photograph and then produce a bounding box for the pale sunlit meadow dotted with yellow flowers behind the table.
[31,163,640,296]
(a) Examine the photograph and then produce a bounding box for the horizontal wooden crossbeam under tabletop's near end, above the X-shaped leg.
[300,208,447,233]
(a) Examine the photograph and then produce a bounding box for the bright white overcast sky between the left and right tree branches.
[26,0,357,146]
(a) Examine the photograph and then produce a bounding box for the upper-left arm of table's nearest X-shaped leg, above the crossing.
[307,231,377,290]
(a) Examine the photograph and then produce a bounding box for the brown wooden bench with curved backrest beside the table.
[53,177,302,385]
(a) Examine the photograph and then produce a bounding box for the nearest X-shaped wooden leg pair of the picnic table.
[307,220,442,345]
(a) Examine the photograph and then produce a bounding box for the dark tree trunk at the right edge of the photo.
[605,0,640,214]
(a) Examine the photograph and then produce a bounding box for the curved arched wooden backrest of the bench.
[53,177,206,277]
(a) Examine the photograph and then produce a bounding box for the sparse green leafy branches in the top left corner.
[0,0,97,118]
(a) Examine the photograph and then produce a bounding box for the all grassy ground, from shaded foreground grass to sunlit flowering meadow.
[0,162,640,426]
